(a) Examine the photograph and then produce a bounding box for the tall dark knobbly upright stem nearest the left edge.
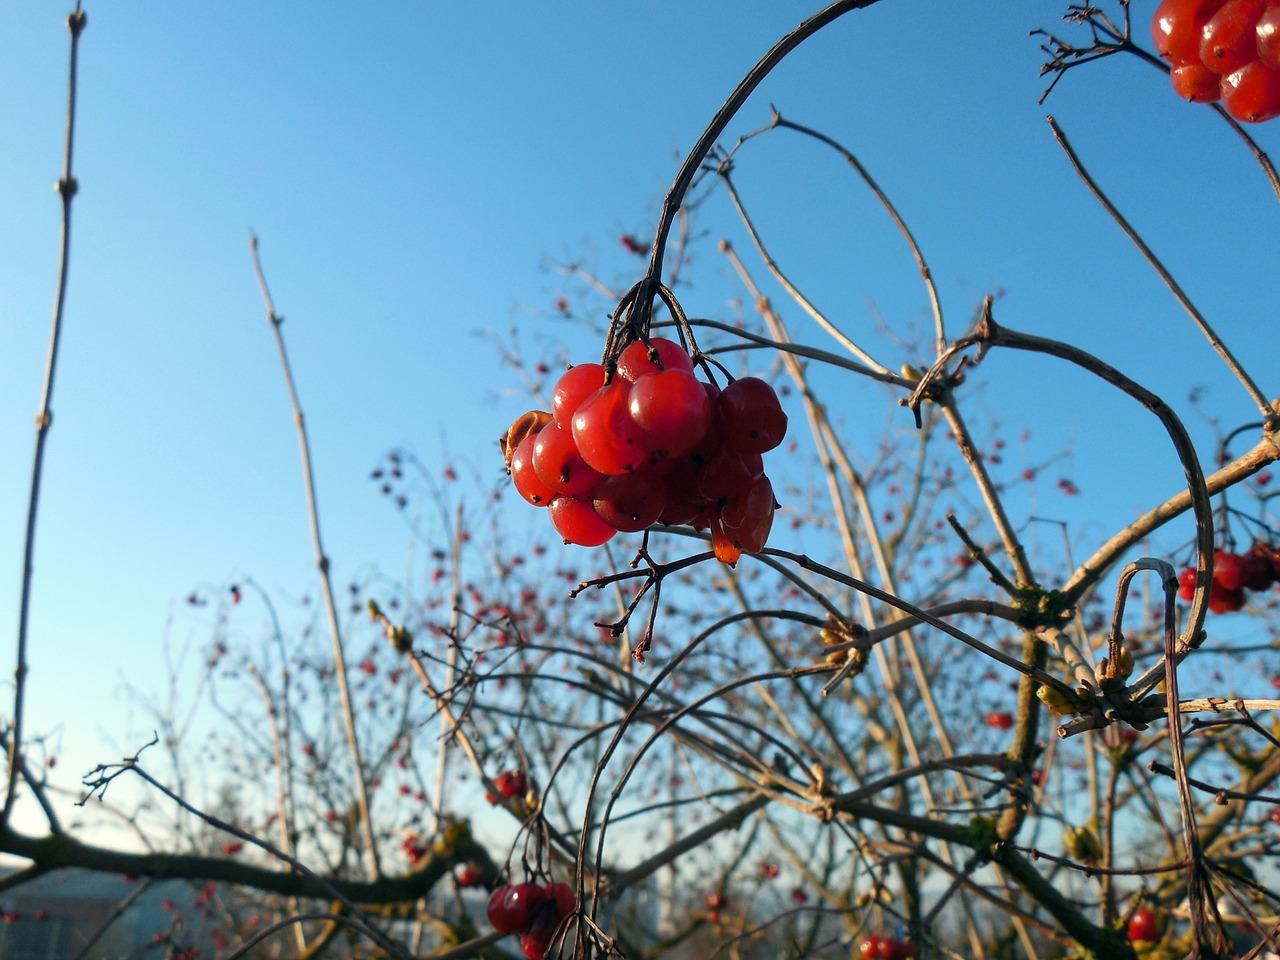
[0,3,88,829]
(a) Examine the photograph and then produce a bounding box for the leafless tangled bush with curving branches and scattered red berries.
[0,0,1280,960]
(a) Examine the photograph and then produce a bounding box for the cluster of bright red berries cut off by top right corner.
[1151,0,1280,123]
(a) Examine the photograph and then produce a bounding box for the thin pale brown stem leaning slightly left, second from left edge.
[248,236,381,878]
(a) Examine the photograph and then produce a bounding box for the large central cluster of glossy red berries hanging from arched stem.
[502,337,787,564]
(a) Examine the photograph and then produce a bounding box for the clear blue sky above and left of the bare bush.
[0,0,1280,834]
